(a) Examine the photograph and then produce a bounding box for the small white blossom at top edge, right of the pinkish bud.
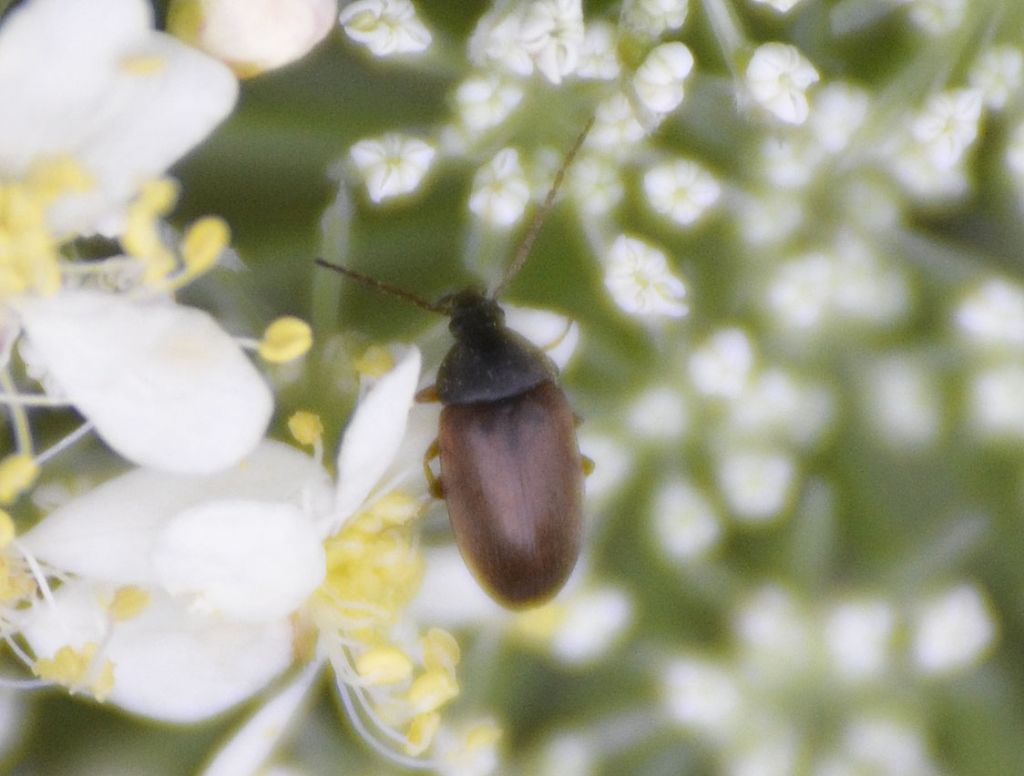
[338,0,430,56]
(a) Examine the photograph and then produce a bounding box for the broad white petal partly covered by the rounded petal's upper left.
[22,441,327,587]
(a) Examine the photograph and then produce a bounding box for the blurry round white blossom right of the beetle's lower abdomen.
[651,480,722,561]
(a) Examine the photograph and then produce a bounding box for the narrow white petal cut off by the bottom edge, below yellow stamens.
[202,662,322,776]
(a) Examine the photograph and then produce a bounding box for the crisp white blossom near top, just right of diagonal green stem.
[746,43,819,124]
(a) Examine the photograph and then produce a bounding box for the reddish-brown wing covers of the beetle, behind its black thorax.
[438,380,583,607]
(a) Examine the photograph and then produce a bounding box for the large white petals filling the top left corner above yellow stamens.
[0,0,238,234]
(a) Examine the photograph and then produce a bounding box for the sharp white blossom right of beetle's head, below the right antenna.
[604,234,689,317]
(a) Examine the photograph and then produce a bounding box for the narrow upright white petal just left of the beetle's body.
[336,348,420,520]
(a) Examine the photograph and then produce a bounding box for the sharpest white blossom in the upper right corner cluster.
[910,89,984,169]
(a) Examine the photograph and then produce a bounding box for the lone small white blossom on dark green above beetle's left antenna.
[349,133,435,203]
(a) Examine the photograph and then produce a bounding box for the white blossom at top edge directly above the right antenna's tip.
[519,0,584,84]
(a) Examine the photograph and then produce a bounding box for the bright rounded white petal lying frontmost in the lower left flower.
[154,500,325,622]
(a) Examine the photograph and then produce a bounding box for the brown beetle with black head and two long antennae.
[316,119,593,609]
